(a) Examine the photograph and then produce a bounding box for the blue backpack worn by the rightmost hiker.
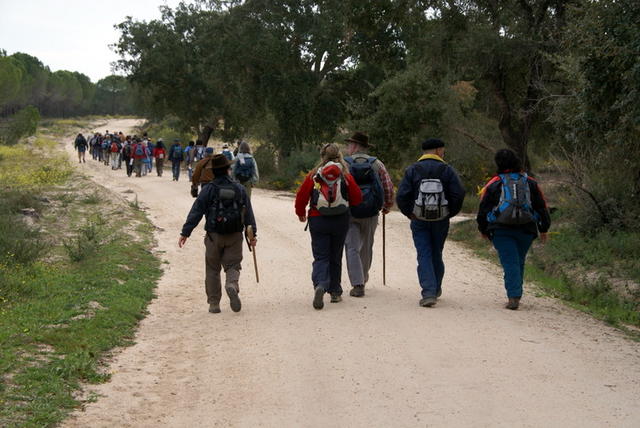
[487,173,537,225]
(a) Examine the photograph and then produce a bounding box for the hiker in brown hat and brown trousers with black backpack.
[178,154,257,313]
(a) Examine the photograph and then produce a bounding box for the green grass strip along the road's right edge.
[449,220,640,338]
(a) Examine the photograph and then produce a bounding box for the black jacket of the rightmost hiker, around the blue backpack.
[476,176,551,237]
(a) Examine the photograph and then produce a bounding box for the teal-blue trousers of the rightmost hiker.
[491,229,535,297]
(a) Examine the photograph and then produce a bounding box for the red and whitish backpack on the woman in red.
[311,162,349,215]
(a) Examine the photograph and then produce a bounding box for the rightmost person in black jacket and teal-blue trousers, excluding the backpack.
[476,149,551,310]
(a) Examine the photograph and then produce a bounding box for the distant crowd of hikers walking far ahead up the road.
[73,130,259,194]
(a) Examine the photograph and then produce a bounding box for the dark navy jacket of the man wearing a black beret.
[396,159,465,218]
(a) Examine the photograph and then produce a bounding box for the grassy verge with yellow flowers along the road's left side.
[0,119,161,427]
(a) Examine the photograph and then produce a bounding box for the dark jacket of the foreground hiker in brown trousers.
[180,176,258,237]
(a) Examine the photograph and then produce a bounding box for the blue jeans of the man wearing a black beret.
[411,219,449,298]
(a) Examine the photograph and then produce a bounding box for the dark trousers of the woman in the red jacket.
[309,212,349,295]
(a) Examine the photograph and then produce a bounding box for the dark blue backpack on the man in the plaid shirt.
[344,156,384,218]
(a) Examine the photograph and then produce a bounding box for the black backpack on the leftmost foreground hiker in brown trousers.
[206,182,244,235]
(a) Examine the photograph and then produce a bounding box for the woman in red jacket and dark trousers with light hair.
[295,143,362,310]
